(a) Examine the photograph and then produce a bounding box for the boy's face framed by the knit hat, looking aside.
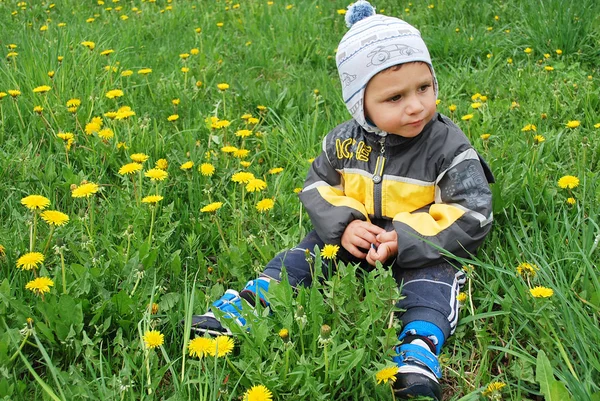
[365,62,436,138]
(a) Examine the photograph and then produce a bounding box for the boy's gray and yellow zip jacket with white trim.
[300,113,494,268]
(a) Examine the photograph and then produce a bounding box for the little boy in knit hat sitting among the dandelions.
[193,1,493,400]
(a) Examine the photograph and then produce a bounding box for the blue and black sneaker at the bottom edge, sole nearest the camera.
[393,336,442,401]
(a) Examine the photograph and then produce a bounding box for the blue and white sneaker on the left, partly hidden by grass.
[191,277,270,336]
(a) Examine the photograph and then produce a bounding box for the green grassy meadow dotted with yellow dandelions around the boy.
[0,0,600,401]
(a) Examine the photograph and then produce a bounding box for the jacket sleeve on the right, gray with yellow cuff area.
[393,148,493,268]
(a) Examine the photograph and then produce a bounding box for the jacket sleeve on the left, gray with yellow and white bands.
[299,141,368,245]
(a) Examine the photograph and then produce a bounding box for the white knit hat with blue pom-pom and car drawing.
[336,0,437,136]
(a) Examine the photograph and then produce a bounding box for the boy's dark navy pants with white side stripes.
[263,231,465,339]
